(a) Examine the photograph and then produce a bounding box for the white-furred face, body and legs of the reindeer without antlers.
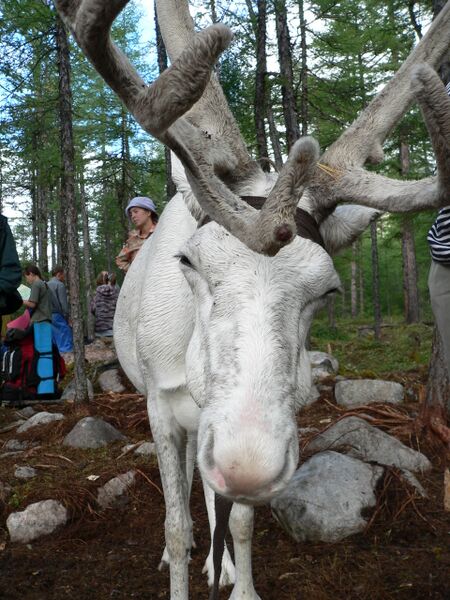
[114,181,346,600]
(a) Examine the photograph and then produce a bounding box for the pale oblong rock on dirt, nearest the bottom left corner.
[6,500,68,543]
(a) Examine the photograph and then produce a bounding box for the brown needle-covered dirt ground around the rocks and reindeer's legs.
[0,374,450,600]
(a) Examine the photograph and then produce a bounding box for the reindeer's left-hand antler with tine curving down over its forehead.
[56,0,317,255]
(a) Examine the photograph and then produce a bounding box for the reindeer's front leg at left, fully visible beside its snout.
[147,391,192,600]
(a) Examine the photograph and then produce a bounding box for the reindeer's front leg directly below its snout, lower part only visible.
[230,502,261,600]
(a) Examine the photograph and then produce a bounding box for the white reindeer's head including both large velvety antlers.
[57,0,450,503]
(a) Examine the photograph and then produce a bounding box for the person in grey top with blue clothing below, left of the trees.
[47,265,73,352]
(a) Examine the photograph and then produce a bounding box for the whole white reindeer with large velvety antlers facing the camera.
[53,0,450,600]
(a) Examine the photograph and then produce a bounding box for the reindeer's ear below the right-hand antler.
[320,204,383,255]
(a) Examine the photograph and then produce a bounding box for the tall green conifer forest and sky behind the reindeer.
[0,0,449,380]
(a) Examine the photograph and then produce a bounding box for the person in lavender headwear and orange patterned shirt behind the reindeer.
[116,196,158,271]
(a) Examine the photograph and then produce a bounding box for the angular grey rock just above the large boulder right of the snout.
[305,417,431,471]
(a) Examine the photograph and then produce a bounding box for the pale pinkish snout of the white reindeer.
[199,431,298,503]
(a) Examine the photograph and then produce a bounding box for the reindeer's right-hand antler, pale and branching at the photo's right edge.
[311,2,450,212]
